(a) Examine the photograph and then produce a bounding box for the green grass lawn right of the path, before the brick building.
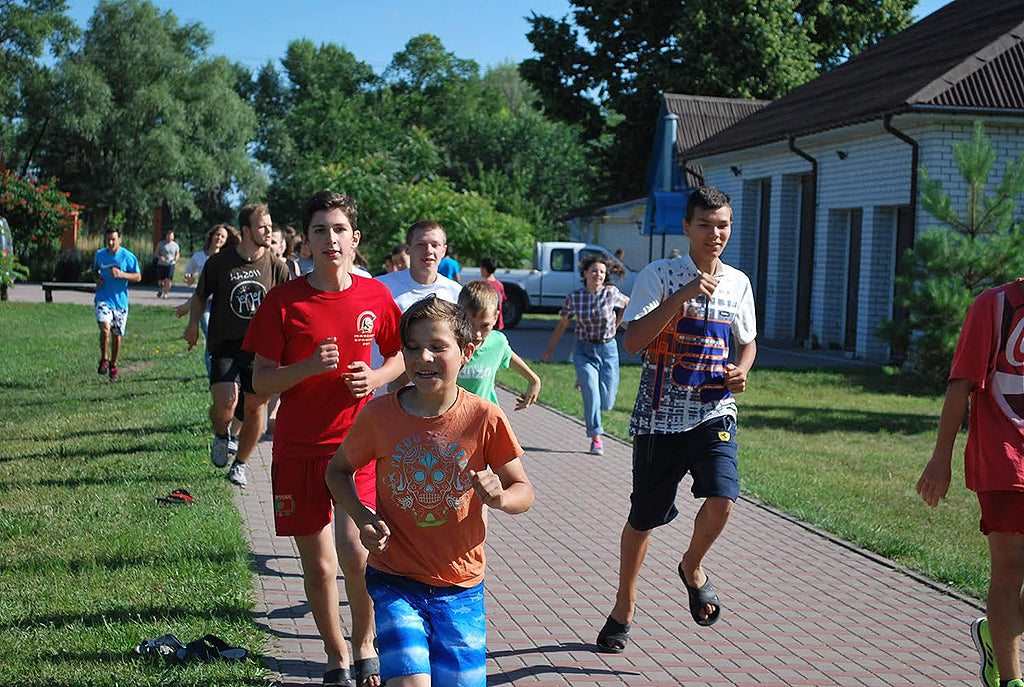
[499,362,988,598]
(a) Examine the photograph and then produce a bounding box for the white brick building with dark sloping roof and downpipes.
[680,0,1024,361]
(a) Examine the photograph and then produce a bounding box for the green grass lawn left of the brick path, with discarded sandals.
[0,303,264,686]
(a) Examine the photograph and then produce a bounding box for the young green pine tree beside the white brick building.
[879,122,1024,388]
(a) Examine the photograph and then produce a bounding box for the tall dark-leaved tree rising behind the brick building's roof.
[519,0,916,200]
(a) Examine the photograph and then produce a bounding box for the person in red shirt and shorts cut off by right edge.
[918,280,1024,687]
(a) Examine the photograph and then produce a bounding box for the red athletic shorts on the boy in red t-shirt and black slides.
[270,456,377,536]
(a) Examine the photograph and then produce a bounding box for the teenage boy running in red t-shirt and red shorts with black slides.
[244,190,403,687]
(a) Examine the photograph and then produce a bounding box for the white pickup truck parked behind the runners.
[495,241,637,328]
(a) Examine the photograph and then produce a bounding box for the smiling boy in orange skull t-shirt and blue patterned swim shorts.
[327,297,534,687]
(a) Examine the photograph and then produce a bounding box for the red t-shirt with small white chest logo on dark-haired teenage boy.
[243,274,401,459]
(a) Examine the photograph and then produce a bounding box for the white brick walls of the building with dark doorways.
[693,117,1024,361]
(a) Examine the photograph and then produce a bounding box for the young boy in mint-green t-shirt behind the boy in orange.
[458,282,541,411]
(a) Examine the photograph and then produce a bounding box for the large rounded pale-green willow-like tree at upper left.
[26,0,265,230]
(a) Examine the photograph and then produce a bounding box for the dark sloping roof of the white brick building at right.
[684,0,1024,159]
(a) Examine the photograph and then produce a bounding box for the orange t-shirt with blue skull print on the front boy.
[342,388,523,587]
